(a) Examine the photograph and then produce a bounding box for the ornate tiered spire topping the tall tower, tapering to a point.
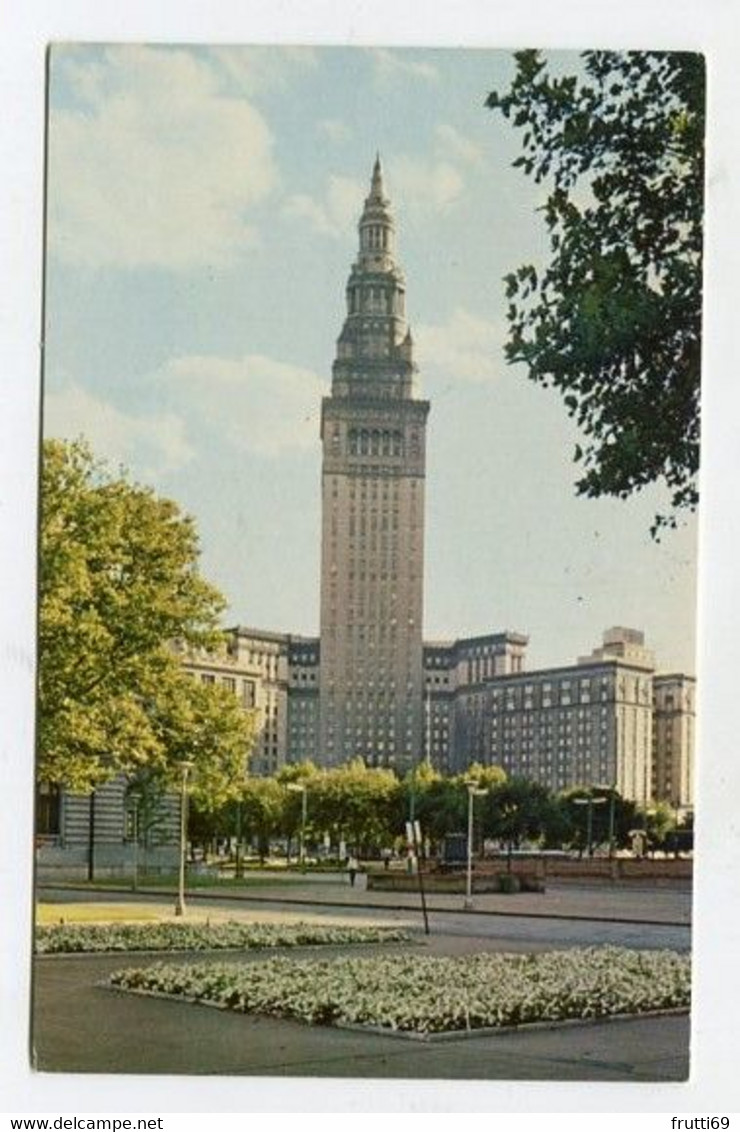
[332,156,416,400]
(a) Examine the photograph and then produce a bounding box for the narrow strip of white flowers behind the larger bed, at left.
[36,920,410,954]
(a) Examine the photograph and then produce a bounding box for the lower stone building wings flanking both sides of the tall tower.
[183,627,696,809]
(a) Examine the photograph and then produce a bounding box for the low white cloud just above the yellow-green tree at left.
[44,384,193,472]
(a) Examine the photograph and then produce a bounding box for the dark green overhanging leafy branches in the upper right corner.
[487,51,705,533]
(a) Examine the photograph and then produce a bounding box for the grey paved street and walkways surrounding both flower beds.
[33,881,690,1081]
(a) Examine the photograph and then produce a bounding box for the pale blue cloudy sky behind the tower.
[44,46,695,671]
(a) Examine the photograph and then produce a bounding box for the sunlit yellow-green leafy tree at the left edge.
[37,440,253,803]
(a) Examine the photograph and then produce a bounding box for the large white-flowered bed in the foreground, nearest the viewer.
[110,947,690,1035]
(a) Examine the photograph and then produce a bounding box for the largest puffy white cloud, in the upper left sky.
[49,46,276,269]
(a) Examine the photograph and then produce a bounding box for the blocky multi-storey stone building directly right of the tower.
[429,631,653,803]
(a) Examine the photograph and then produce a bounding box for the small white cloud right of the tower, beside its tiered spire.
[414,307,506,381]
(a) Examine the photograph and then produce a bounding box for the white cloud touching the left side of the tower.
[153,354,328,456]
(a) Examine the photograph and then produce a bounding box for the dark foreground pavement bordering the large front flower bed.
[33,936,688,1081]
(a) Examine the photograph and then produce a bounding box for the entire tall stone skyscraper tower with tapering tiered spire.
[319,158,429,771]
